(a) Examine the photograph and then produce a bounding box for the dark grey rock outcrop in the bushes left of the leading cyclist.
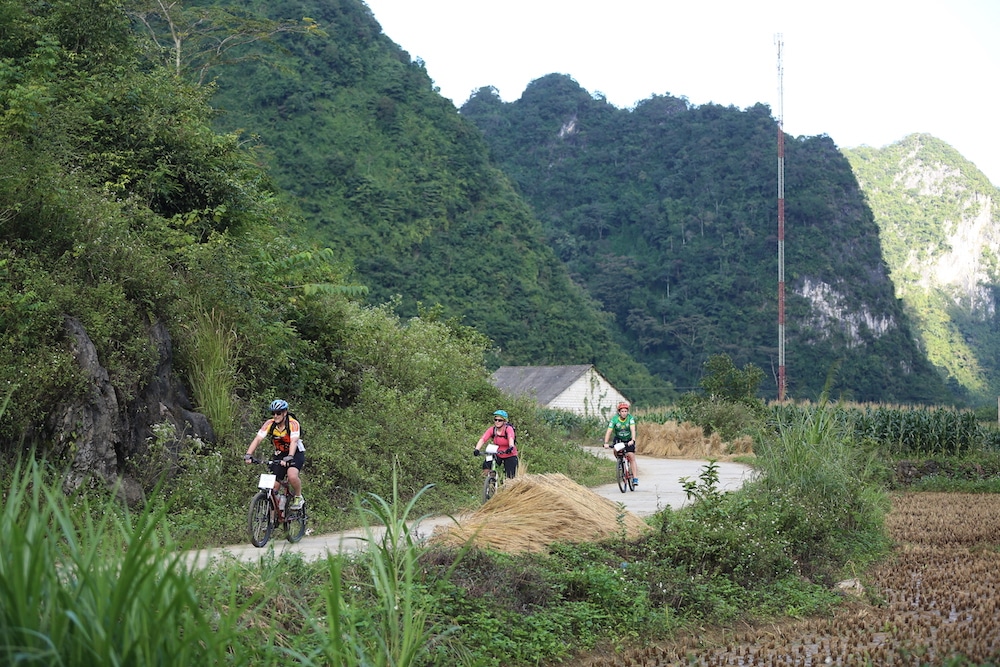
[42,318,215,502]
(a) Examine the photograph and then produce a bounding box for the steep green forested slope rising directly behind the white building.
[207,0,674,403]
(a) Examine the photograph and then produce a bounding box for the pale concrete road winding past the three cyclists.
[192,447,753,566]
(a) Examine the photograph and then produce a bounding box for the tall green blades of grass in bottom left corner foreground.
[0,462,261,667]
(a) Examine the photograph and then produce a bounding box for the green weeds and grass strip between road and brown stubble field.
[7,352,972,665]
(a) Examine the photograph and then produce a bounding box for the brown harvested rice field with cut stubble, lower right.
[571,493,1000,667]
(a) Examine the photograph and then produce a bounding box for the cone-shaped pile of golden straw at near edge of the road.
[429,474,649,553]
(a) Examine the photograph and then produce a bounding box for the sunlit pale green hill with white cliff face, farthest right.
[845,134,1000,404]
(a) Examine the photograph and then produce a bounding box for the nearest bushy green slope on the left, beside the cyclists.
[0,0,604,520]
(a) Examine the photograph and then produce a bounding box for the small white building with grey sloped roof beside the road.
[492,364,628,419]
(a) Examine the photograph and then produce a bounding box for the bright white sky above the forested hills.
[366,0,1000,186]
